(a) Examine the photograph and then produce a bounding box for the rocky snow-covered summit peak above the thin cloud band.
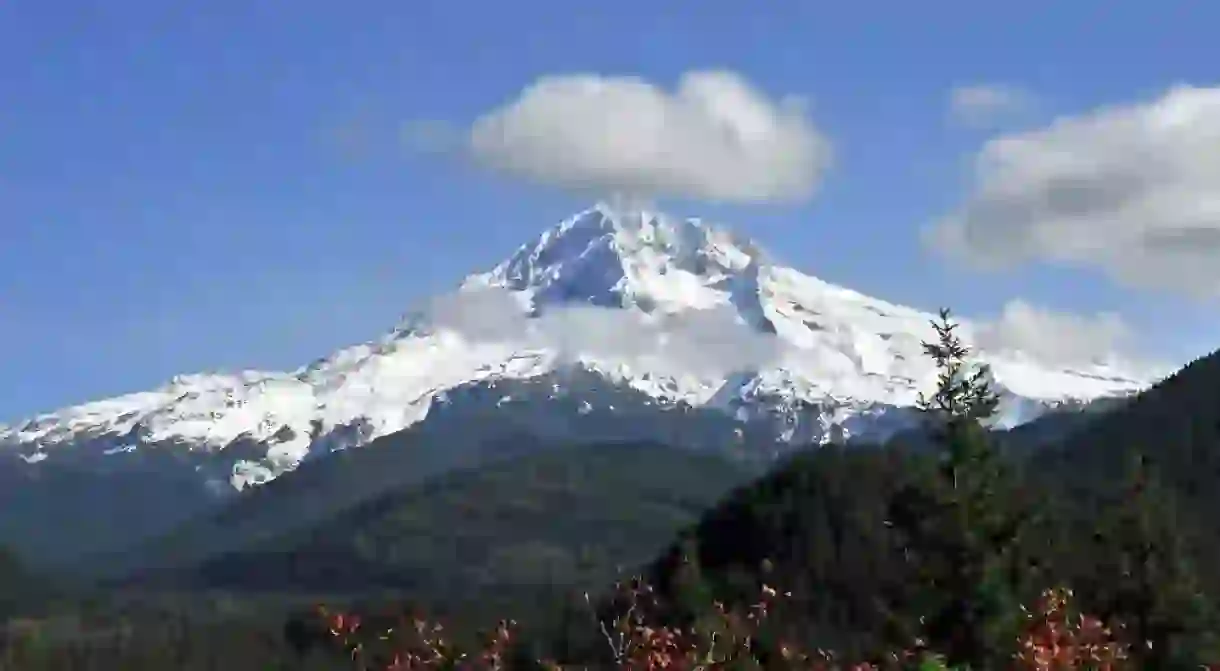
[466,201,764,312]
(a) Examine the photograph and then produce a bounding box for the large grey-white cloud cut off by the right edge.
[926,87,1220,298]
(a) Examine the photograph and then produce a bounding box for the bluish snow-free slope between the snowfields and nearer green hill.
[81,390,771,576]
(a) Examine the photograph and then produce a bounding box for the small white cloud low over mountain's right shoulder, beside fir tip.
[975,300,1132,366]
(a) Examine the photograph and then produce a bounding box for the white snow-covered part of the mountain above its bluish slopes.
[0,205,1157,489]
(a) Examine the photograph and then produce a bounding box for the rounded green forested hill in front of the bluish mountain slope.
[136,443,755,614]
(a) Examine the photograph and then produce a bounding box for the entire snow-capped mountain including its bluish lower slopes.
[0,205,1155,561]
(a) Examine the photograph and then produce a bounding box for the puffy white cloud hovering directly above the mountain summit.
[414,71,831,203]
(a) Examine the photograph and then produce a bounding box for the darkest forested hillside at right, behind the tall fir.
[651,322,1220,667]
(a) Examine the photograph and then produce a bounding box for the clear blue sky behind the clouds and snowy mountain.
[0,0,1220,420]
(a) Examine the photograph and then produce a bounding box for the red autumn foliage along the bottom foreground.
[320,578,1151,671]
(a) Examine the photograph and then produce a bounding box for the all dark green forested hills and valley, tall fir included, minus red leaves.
[0,314,1220,671]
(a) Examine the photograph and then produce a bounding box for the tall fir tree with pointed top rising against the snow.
[888,310,1032,670]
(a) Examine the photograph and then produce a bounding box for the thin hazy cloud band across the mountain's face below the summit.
[427,288,778,378]
